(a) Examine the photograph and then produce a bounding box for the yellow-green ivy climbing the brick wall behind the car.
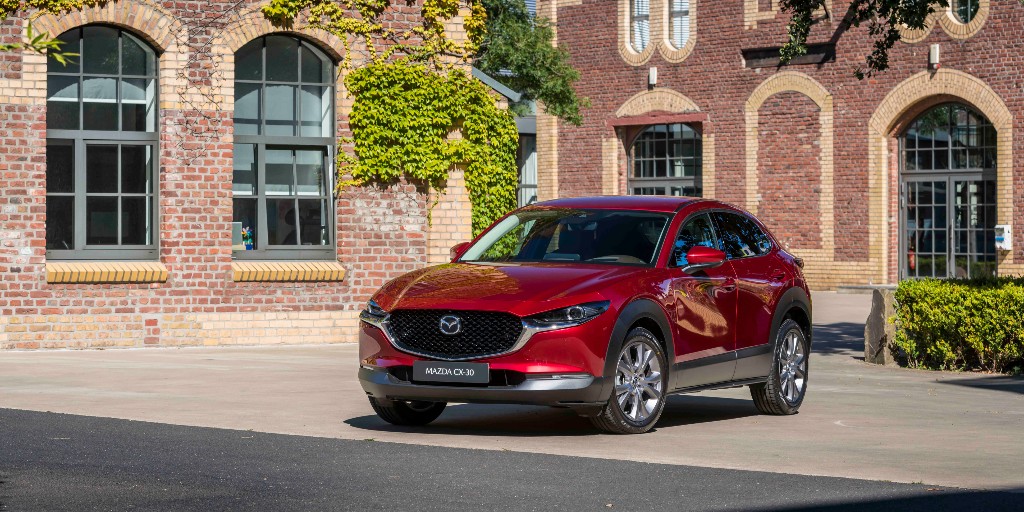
[263,0,518,234]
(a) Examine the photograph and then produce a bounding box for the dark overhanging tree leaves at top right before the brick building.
[779,0,949,79]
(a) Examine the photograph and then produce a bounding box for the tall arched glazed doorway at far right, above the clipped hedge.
[900,103,997,279]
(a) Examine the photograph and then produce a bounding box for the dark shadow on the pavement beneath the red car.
[345,395,758,437]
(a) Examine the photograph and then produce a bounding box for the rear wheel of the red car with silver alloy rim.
[751,319,810,416]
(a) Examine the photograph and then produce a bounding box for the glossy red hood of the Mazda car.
[375,263,645,316]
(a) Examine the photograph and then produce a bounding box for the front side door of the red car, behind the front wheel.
[669,213,736,389]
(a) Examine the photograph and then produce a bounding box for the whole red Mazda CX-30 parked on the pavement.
[359,197,811,433]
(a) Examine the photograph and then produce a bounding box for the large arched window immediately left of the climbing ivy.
[232,35,335,259]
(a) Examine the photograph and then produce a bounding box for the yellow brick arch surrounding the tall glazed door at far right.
[867,68,1016,273]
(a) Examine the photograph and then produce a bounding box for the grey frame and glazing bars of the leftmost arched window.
[44,24,161,261]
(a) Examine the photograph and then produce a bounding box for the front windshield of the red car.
[461,209,669,265]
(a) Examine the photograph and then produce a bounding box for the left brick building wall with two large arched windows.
[0,0,470,349]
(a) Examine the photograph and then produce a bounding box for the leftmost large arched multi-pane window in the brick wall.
[46,26,159,259]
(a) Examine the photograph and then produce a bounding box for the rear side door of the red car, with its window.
[712,212,790,379]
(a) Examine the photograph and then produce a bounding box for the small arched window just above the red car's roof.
[629,124,701,197]
